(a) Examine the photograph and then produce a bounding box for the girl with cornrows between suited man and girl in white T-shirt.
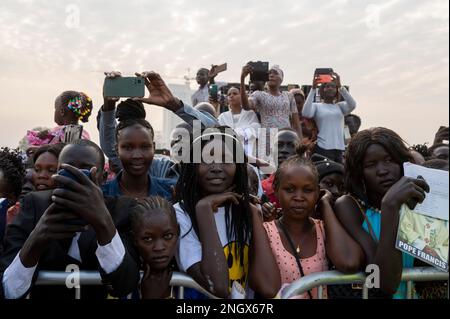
[130,196,180,299]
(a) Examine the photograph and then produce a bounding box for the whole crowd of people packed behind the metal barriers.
[0,64,449,299]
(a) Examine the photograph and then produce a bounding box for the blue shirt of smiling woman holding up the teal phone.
[102,171,175,201]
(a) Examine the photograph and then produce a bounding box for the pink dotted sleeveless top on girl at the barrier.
[263,219,329,299]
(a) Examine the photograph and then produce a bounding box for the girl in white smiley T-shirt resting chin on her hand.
[175,127,280,298]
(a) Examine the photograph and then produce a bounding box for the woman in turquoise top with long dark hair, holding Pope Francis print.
[335,127,429,298]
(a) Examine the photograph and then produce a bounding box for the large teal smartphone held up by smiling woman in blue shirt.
[103,77,145,97]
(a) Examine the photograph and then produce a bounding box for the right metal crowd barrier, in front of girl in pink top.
[281,267,448,299]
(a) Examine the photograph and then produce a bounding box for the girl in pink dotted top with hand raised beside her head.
[264,148,363,299]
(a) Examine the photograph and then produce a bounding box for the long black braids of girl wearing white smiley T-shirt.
[176,126,252,264]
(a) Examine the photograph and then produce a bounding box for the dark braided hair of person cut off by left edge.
[0,147,25,197]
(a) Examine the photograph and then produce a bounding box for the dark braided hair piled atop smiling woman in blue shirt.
[116,99,155,139]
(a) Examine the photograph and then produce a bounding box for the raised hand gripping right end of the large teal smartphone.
[134,71,182,112]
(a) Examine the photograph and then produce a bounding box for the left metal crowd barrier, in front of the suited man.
[35,271,218,299]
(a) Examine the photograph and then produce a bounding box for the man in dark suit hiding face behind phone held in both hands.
[0,140,139,299]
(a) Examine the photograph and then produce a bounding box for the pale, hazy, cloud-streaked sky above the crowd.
[0,0,449,147]
